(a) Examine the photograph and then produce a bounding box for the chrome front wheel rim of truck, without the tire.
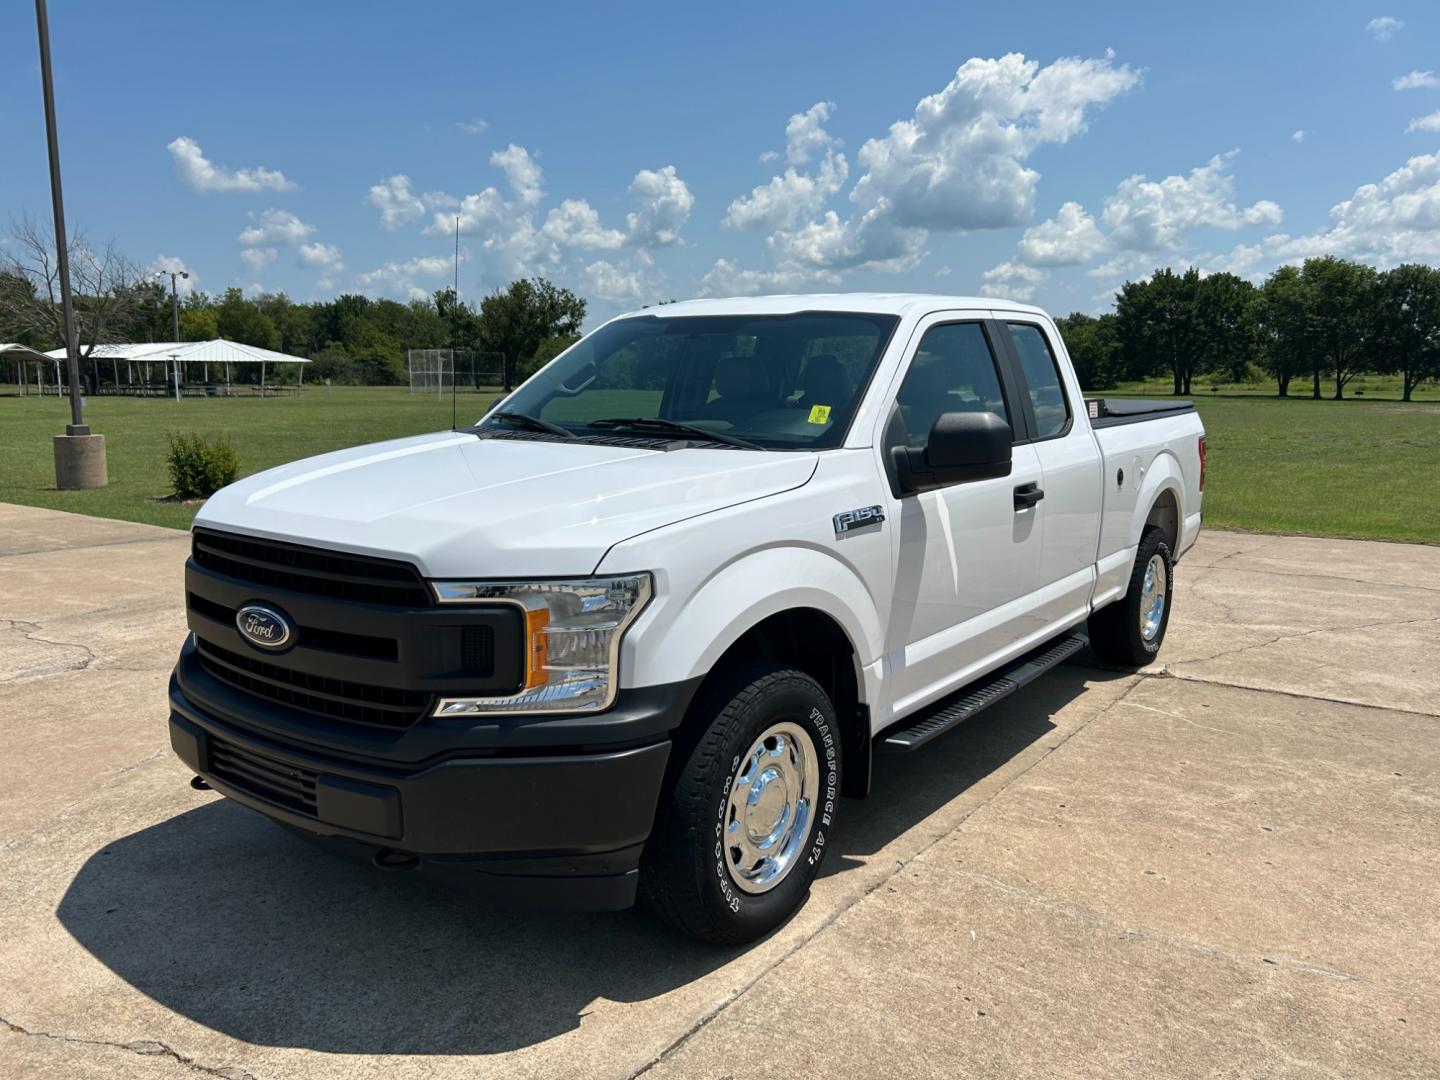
[724,723,821,893]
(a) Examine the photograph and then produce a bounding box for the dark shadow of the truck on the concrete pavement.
[58,667,1107,1054]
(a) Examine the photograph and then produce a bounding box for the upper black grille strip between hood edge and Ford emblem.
[192,528,431,608]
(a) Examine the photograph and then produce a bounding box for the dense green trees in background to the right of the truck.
[1058,256,1440,402]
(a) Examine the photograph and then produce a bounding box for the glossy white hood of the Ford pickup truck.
[196,432,815,577]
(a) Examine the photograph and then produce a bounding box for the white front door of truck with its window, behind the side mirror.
[878,312,1041,716]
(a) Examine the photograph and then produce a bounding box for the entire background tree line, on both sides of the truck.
[0,219,1440,402]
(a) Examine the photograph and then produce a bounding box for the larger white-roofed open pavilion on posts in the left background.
[35,338,310,397]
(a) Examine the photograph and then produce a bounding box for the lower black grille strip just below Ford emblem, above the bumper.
[196,638,431,729]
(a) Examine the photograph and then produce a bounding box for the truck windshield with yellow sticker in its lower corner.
[482,311,899,449]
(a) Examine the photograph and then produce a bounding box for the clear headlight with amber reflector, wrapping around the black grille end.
[431,573,651,716]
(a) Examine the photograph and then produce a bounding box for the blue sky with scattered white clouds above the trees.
[0,0,1440,325]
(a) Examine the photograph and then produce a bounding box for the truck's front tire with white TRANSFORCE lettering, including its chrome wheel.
[639,664,841,945]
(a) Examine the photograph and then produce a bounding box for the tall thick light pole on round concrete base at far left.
[35,0,108,491]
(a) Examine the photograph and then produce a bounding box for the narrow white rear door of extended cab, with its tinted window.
[995,312,1103,631]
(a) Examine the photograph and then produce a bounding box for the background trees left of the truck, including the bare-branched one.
[0,219,586,390]
